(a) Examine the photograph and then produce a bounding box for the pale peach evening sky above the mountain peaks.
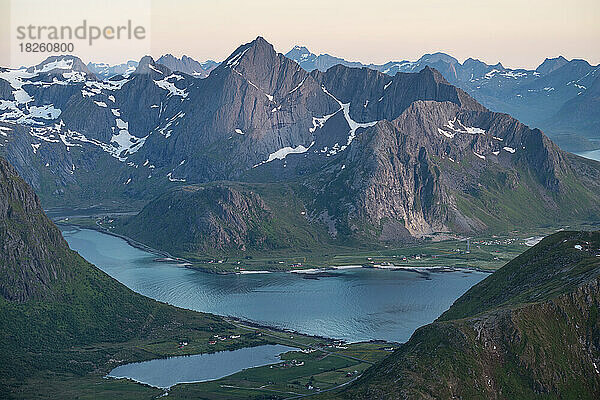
[0,0,600,68]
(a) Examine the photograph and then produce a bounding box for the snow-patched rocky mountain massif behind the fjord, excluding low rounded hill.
[0,37,600,247]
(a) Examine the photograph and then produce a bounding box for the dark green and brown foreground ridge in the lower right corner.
[340,232,600,399]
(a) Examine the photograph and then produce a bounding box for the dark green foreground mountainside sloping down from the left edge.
[0,158,264,398]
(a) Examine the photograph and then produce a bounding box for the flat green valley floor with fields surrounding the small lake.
[11,319,395,399]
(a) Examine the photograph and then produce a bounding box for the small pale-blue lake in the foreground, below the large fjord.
[108,344,298,389]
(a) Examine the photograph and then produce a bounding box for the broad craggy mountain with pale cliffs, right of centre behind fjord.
[304,101,594,239]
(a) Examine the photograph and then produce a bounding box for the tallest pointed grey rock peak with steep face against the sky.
[135,37,336,182]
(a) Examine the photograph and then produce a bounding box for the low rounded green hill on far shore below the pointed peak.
[115,182,331,258]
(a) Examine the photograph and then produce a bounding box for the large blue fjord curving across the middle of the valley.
[63,228,487,342]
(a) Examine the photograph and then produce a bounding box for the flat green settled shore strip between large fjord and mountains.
[55,214,600,274]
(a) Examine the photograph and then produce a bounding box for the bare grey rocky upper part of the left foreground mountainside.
[0,158,72,302]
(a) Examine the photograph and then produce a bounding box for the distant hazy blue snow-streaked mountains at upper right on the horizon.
[286,46,600,151]
